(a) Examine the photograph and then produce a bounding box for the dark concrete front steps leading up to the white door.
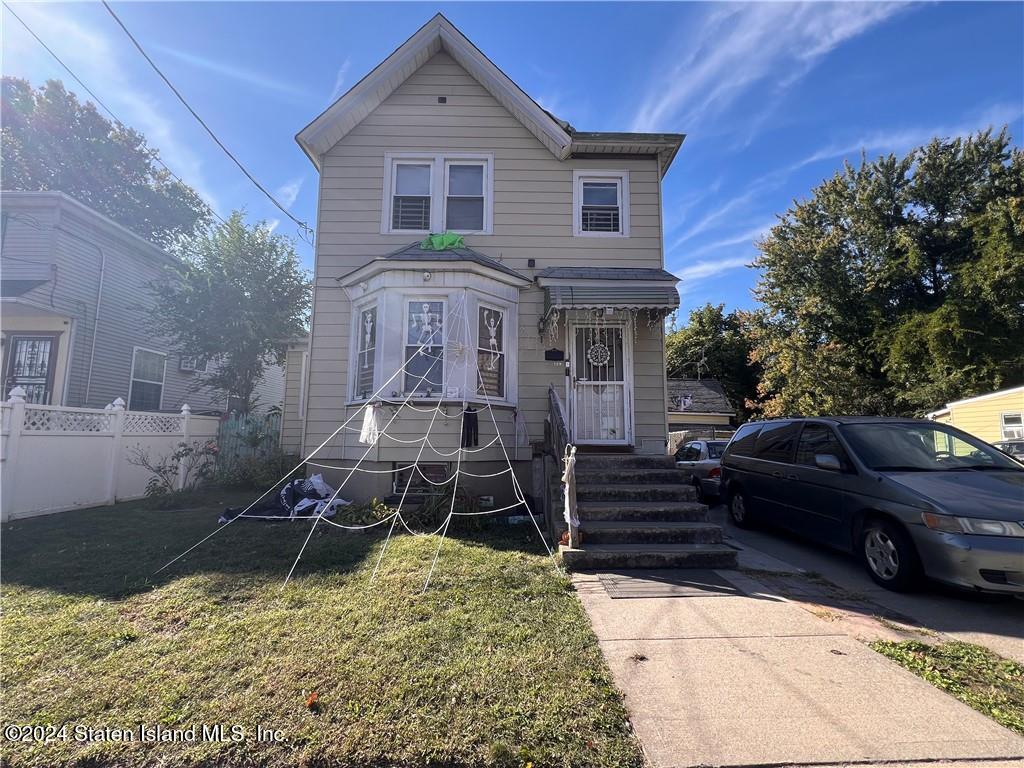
[560,454,736,569]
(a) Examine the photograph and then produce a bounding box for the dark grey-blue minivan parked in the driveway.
[722,417,1024,594]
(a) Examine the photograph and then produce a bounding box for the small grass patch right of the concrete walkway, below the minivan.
[870,640,1024,735]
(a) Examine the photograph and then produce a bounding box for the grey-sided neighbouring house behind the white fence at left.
[0,190,284,413]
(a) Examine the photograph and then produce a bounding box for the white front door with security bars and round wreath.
[569,324,633,445]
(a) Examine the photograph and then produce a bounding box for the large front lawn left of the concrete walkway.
[0,495,643,768]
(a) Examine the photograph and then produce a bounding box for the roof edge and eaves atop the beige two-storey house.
[295,13,686,176]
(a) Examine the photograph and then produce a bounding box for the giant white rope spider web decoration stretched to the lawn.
[156,291,557,592]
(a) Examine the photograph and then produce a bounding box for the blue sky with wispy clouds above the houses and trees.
[2,2,1024,319]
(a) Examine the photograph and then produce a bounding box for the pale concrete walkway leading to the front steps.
[573,570,1024,768]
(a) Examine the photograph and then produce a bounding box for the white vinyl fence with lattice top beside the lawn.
[0,387,220,521]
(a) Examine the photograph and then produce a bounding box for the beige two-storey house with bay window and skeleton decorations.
[283,14,683,505]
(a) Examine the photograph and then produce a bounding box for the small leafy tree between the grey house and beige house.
[150,211,311,411]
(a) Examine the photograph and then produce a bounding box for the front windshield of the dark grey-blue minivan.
[840,422,1024,472]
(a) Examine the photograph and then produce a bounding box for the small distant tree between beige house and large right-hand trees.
[665,303,760,417]
